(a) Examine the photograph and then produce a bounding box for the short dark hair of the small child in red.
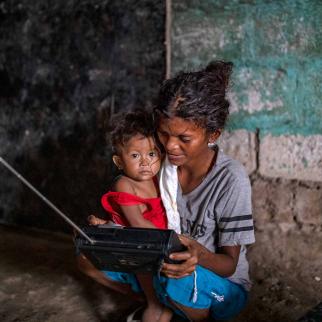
[106,108,155,153]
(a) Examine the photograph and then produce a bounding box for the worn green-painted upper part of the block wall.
[172,0,322,136]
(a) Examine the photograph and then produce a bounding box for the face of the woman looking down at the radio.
[158,117,209,166]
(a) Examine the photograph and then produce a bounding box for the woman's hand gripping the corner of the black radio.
[161,235,203,278]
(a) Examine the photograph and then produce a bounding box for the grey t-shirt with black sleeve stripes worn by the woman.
[177,151,255,290]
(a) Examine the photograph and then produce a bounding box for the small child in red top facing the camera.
[88,110,172,322]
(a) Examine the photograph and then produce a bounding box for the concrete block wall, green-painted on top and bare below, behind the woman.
[171,0,322,231]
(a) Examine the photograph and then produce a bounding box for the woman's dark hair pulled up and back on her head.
[155,61,233,133]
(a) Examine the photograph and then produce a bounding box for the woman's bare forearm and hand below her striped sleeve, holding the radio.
[162,235,240,278]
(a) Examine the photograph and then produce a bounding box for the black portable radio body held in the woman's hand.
[75,225,185,273]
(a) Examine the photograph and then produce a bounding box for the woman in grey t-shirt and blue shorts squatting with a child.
[80,62,254,321]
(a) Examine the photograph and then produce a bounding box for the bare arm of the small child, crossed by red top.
[114,177,156,228]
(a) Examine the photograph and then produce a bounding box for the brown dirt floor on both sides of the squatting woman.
[0,226,322,322]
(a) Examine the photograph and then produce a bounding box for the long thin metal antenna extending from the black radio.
[0,156,95,244]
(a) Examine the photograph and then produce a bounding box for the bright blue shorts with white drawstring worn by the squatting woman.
[103,265,248,320]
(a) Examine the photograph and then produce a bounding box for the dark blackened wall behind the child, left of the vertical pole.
[0,0,165,231]
